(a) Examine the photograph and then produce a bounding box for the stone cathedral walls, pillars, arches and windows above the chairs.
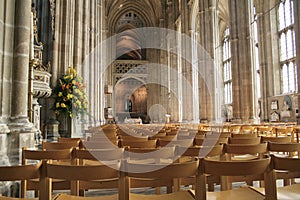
[0,0,300,198]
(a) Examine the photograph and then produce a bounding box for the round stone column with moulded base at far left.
[8,0,35,164]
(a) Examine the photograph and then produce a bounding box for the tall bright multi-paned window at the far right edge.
[278,0,298,94]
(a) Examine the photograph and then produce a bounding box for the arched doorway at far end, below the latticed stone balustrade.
[114,77,148,123]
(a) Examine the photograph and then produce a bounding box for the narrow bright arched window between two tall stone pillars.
[223,27,232,104]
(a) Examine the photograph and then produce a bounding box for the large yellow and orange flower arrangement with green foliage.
[53,67,88,117]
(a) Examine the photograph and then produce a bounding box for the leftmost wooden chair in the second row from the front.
[21,147,72,197]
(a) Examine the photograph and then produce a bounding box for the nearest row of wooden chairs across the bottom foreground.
[0,151,300,200]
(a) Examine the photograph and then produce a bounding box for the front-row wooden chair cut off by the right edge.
[259,155,300,200]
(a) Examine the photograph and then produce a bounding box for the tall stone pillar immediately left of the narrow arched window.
[198,0,218,122]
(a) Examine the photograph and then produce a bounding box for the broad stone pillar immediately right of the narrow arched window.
[228,0,255,123]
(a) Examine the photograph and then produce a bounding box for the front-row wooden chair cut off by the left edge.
[0,162,43,200]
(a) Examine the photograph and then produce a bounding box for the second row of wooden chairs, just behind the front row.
[18,139,300,197]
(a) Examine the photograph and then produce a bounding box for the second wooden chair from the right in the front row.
[195,157,271,200]
